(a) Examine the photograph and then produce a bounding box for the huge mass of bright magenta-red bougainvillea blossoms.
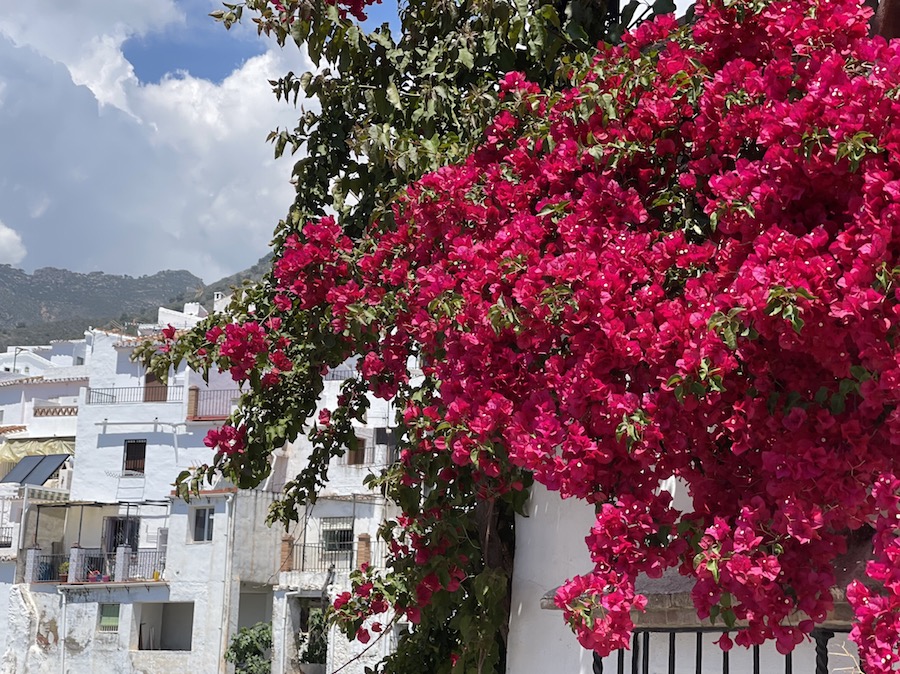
[144,0,900,672]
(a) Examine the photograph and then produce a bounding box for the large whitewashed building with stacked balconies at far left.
[0,306,281,674]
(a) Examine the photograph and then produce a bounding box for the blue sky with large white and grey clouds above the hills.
[0,0,685,282]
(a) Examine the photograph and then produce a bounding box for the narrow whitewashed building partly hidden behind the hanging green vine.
[272,362,402,674]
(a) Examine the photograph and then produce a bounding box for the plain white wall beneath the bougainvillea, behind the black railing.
[507,484,859,674]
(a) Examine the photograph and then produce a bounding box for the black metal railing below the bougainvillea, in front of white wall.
[592,628,860,674]
